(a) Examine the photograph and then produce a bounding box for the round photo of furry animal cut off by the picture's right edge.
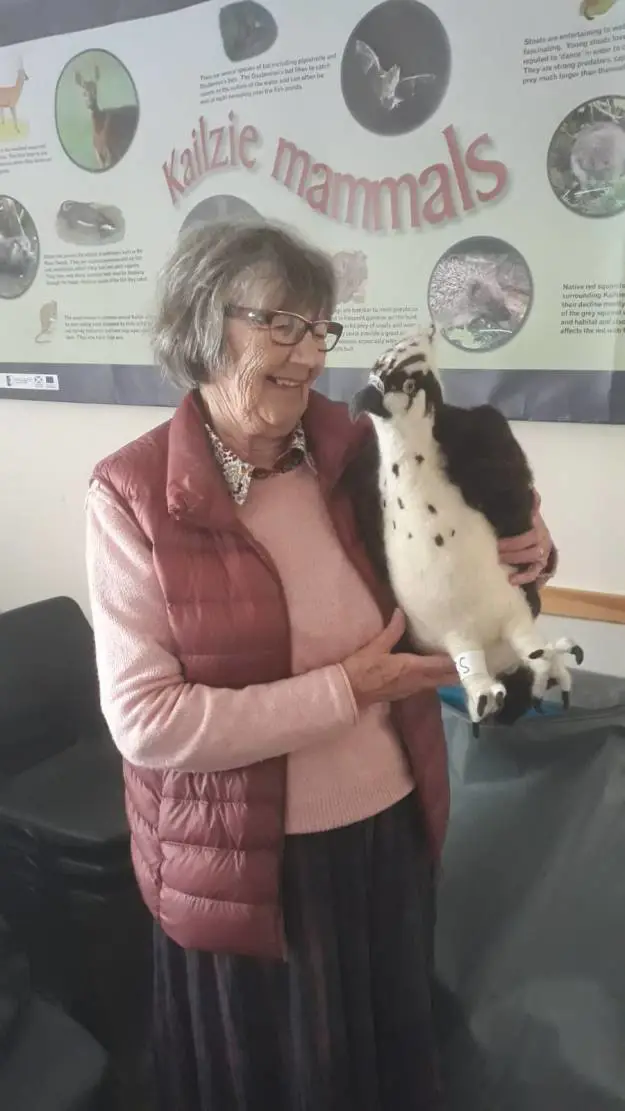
[547,97,625,217]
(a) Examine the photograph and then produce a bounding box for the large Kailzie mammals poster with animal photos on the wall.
[0,0,625,422]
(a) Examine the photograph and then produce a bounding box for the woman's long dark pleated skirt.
[154,797,443,1111]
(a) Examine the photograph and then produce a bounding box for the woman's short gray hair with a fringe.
[153,223,335,389]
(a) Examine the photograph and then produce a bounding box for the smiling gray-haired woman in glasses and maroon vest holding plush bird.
[88,226,551,1111]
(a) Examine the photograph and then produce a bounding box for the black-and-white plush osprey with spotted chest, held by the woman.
[351,327,583,732]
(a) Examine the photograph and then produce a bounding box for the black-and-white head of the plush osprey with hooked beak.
[351,324,443,423]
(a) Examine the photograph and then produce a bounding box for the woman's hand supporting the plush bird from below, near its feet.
[343,610,458,710]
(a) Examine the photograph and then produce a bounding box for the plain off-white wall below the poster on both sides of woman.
[0,401,625,674]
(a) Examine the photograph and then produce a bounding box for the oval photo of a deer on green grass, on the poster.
[57,50,139,172]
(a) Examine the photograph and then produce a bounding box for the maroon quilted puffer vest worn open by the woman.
[93,393,448,958]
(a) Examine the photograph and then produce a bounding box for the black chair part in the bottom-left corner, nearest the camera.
[0,919,111,1111]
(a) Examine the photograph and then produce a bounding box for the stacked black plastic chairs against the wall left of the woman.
[0,598,150,1058]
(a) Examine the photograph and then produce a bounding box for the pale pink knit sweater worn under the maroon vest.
[87,466,414,833]
